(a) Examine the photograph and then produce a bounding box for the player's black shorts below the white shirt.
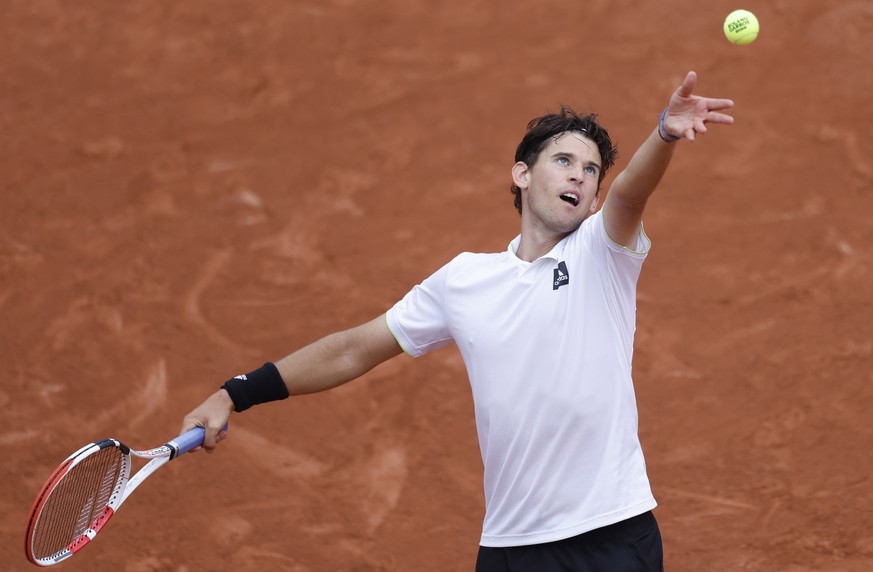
[476,511,664,572]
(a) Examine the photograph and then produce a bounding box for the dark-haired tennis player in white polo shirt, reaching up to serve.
[181,72,733,572]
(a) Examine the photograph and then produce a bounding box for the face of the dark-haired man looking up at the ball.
[512,132,601,235]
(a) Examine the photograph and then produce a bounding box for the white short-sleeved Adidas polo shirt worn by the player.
[387,212,656,547]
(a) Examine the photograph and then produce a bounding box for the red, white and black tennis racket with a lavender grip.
[24,425,227,566]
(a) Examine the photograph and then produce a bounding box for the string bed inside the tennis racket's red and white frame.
[33,447,124,558]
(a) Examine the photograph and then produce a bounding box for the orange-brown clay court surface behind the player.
[0,0,873,572]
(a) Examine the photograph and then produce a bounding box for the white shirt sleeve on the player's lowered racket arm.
[386,263,452,357]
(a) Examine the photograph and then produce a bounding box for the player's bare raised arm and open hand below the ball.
[603,71,734,247]
